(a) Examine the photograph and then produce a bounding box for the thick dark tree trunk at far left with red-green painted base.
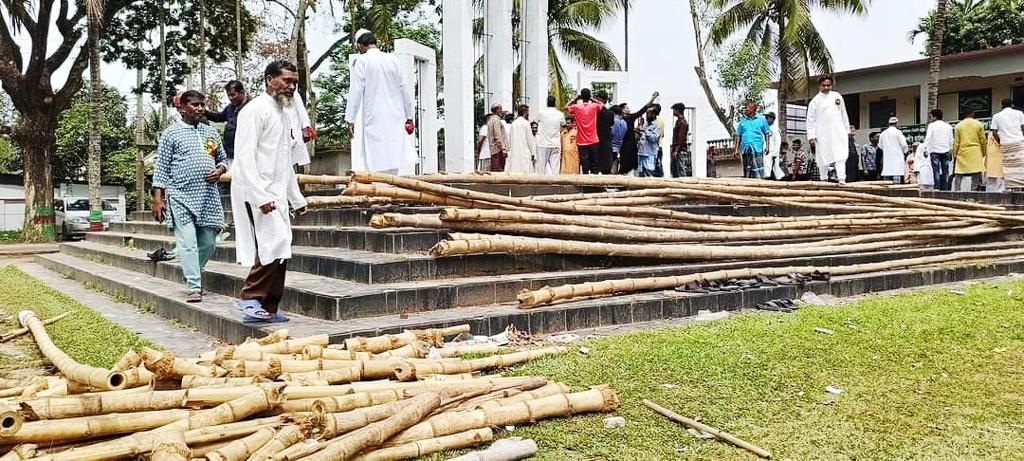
[11,115,57,242]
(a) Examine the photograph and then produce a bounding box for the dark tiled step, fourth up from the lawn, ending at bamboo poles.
[110,221,447,253]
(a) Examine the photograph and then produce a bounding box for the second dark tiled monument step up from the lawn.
[61,230,1013,320]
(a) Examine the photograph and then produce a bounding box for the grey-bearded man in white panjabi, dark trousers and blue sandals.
[230,60,306,323]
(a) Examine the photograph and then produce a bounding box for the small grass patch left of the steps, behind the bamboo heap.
[0,265,154,376]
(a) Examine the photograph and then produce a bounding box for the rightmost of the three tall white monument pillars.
[520,0,550,108]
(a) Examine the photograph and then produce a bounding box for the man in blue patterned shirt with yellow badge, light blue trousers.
[153,90,227,302]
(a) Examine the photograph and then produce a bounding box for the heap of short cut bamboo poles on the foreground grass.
[0,319,617,461]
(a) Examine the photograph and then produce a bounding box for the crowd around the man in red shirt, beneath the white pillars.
[474,88,693,177]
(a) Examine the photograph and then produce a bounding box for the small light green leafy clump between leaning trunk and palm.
[715,40,771,118]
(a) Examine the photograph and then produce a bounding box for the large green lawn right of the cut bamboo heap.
[514,282,1024,460]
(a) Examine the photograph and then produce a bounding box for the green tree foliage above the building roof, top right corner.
[909,0,1024,56]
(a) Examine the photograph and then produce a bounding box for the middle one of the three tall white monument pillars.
[481,0,515,111]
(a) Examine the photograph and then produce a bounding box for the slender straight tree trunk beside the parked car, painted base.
[88,15,103,232]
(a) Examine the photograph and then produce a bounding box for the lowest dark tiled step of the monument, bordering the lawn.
[36,244,1024,342]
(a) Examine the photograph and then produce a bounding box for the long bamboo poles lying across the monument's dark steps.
[327,172,1024,308]
